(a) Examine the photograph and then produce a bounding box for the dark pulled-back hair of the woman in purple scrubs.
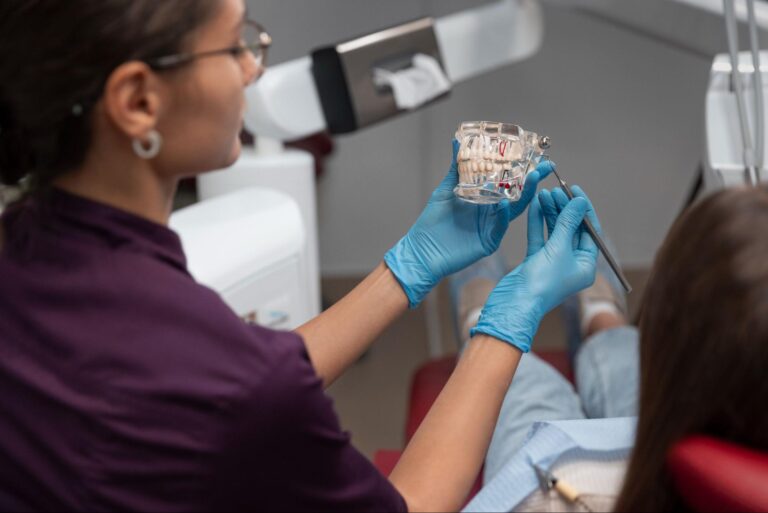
[0,0,218,185]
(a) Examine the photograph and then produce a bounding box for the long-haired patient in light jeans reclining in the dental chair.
[454,187,768,511]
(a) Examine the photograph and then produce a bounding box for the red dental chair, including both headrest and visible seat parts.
[374,351,768,512]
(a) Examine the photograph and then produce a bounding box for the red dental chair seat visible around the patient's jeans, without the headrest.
[373,351,573,504]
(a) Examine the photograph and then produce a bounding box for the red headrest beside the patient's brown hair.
[667,436,768,511]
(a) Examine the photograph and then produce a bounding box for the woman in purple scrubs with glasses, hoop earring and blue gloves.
[0,0,596,511]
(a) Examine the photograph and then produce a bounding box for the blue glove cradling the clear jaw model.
[384,139,552,308]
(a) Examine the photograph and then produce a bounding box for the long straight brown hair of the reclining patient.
[616,187,768,511]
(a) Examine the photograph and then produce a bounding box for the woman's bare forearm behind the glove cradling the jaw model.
[296,263,408,387]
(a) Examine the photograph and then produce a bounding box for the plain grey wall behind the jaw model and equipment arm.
[249,0,744,275]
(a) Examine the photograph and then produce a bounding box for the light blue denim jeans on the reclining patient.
[484,326,639,483]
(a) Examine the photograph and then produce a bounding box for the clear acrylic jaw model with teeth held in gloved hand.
[454,121,549,204]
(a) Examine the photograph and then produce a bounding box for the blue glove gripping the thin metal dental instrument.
[470,187,600,353]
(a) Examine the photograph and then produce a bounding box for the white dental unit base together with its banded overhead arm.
[171,0,543,352]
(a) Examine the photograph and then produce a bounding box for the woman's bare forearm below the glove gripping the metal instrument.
[390,335,522,511]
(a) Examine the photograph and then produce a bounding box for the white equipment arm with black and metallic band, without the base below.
[245,0,543,140]
